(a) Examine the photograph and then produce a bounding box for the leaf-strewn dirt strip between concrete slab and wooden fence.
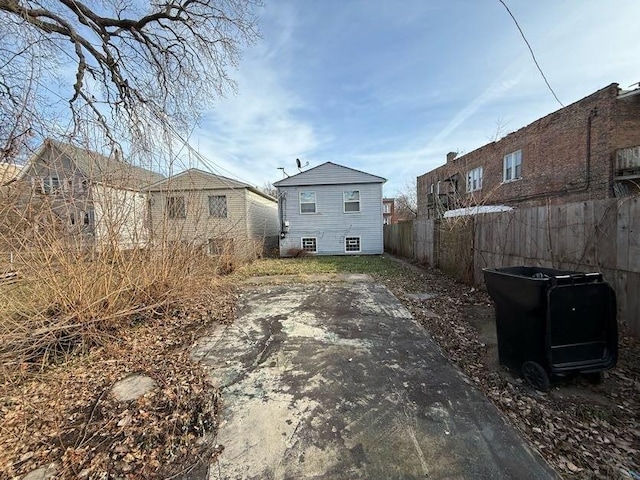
[380,259,640,479]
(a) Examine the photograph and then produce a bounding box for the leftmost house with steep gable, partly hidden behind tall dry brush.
[16,139,163,249]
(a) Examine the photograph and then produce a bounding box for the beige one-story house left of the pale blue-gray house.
[149,168,278,258]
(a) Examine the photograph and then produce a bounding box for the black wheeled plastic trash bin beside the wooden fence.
[483,266,618,391]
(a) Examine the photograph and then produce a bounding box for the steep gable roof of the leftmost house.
[21,138,164,190]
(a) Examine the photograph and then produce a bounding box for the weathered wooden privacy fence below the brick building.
[385,197,640,334]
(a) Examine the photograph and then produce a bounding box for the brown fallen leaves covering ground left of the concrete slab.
[0,287,235,479]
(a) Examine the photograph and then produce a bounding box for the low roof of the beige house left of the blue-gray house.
[147,168,276,202]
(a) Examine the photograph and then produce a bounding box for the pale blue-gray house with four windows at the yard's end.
[273,162,386,257]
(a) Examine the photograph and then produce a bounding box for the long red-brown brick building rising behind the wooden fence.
[417,83,640,218]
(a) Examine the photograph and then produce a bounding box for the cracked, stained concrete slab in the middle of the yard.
[193,283,557,480]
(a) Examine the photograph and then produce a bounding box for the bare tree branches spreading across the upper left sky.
[0,0,261,160]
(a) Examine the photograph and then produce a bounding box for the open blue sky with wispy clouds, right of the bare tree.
[190,0,640,196]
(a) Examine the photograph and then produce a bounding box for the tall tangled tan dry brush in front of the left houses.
[0,183,239,381]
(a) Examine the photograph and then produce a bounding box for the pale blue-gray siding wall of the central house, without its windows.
[278,183,383,256]
